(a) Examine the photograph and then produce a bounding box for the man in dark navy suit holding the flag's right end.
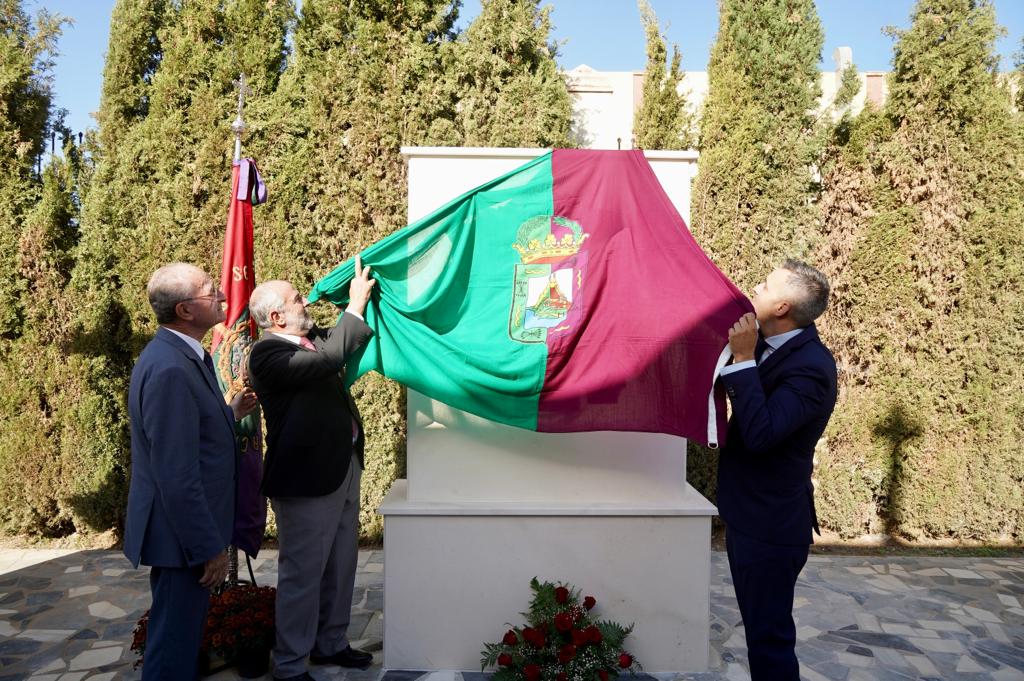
[718,260,836,681]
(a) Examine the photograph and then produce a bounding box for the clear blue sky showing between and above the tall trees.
[26,0,1024,139]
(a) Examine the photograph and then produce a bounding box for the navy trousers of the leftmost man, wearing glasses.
[142,565,210,681]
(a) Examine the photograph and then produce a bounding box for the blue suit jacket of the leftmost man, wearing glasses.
[124,327,238,567]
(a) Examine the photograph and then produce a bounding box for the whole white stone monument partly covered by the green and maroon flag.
[379,148,716,672]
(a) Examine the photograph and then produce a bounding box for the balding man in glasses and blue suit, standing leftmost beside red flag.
[125,263,256,681]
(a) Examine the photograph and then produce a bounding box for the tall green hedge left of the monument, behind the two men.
[0,0,571,540]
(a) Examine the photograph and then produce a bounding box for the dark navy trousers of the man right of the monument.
[725,527,809,681]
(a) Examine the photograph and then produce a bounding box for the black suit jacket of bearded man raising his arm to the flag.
[249,314,373,498]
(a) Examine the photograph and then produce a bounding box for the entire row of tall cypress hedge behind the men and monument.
[0,0,1024,542]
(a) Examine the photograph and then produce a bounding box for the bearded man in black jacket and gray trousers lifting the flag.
[249,256,375,681]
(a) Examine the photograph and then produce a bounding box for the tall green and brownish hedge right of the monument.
[690,0,1024,542]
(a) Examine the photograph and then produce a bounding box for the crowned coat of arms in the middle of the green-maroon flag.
[509,215,589,343]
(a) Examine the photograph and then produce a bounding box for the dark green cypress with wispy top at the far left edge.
[0,0,76,535]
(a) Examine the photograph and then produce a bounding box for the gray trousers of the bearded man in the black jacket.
[270,456,362,678]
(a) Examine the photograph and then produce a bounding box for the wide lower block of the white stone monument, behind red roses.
[379,480,716,672]
